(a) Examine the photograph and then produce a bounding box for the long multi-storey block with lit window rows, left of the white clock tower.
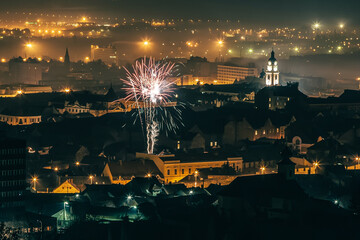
[217,65,259,84]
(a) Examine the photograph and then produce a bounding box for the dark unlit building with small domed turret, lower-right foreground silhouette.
[218,157,308,219]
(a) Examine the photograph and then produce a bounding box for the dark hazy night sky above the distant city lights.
[0,0,360,25]
